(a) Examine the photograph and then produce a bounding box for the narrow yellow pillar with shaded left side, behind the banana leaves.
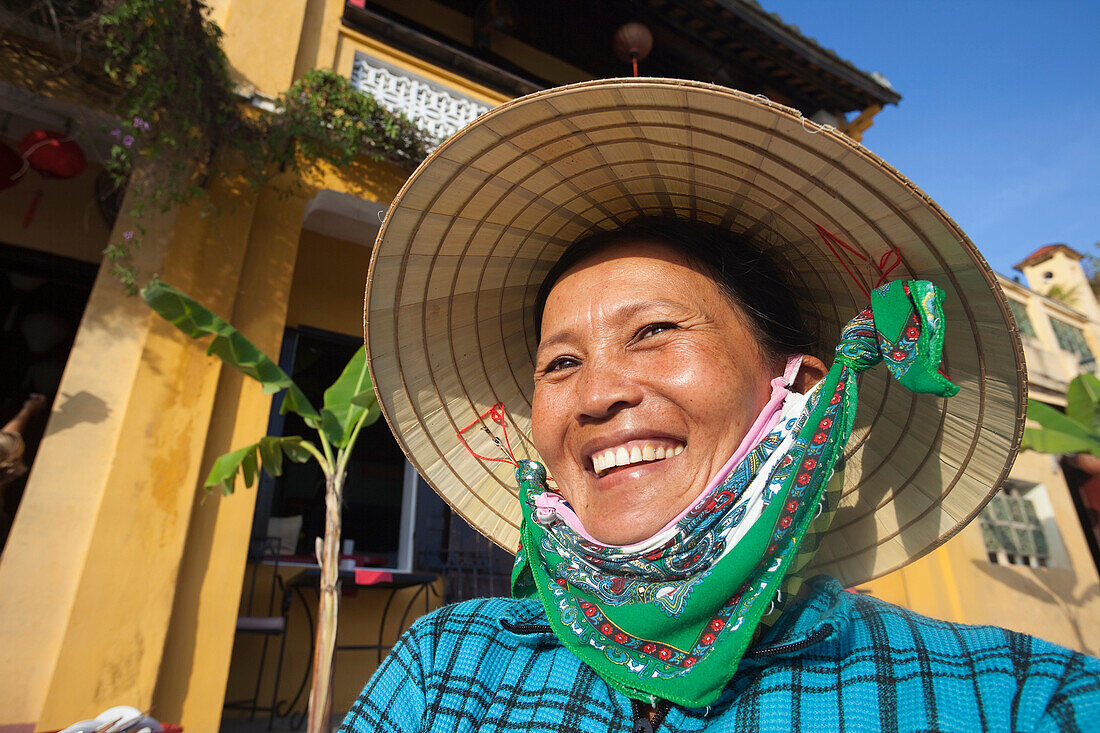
[153,181,306,731]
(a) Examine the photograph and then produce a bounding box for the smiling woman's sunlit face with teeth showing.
[532,241,783,545]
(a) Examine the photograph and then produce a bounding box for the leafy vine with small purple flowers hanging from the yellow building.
[13,0,430,293]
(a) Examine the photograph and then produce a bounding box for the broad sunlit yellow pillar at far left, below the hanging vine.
[0,173,261,731]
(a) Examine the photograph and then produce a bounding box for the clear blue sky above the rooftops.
[760,0,1100,276]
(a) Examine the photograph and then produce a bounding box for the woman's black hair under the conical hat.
[535,216,816,357]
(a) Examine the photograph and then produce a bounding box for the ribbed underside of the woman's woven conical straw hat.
[365,78,1026,584]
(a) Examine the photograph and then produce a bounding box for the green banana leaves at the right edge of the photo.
[1023,374,1100,458]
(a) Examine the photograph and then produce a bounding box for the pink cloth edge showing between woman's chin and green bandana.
[532,354,802,548]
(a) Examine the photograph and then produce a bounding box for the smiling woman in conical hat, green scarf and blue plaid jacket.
[345,79,1100,731]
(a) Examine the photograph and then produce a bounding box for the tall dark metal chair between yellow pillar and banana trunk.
[223,537,290,731]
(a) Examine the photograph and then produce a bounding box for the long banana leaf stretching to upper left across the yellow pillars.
[141,280,321,427]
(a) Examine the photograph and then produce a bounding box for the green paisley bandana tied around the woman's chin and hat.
[513,281,958,708]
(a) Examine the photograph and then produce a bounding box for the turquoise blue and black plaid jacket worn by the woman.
[340,576,1100,733]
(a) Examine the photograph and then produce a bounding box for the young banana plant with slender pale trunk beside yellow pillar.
[141,280,381,733]
